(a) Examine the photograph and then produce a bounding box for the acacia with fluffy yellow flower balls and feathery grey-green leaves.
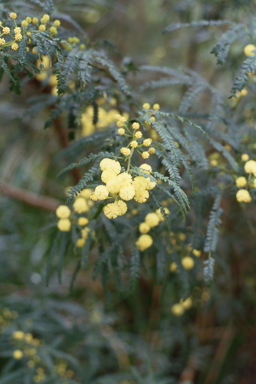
[0,1,256,383]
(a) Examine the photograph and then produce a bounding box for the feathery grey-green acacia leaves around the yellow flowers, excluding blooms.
[0,2,249,302]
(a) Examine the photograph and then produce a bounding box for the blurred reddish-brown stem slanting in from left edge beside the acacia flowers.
[0,181,61,211]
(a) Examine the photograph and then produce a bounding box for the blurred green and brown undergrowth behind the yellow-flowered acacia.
[0,0,256,384]
